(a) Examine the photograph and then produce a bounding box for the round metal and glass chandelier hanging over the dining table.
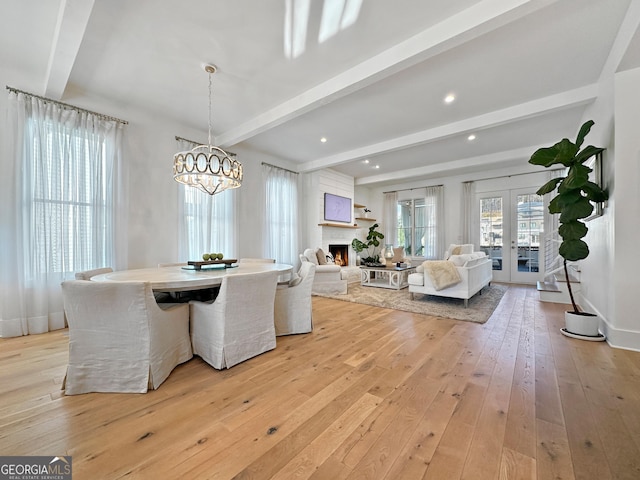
[173,65,242,195]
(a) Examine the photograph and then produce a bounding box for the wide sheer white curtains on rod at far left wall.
[0,91,128,337]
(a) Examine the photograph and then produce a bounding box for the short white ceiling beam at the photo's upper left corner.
[44,0,95,100]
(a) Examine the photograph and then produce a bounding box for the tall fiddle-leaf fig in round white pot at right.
[529,120,608,340]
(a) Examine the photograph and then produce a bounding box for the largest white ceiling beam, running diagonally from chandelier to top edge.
[216,0,557,146]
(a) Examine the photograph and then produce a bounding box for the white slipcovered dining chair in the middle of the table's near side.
[189,271,278,369]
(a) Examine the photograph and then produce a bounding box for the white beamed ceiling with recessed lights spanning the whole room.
[0,0,640,185]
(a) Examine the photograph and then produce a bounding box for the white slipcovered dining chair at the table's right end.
[274,262,316,336]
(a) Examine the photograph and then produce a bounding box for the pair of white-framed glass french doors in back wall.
[478,189,544,283]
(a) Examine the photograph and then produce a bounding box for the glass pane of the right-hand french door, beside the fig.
[516,193,544,272]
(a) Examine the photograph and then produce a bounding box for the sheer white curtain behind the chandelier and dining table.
[176,138,238,262]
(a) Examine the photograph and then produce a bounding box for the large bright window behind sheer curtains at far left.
[22,118,119,276]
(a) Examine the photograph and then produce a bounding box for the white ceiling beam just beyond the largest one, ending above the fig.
[298,84,599,172]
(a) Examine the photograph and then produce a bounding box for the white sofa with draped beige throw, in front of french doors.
[409,245,493,307]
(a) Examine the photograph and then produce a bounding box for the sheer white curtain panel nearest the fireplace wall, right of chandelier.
[262,163,300,265]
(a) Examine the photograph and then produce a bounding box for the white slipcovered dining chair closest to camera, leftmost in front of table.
[62,280,193,395]
